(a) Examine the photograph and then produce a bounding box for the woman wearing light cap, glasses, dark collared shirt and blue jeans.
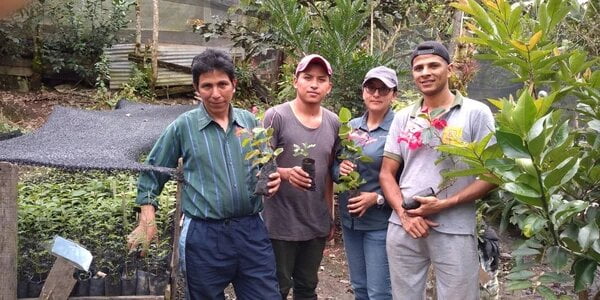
[333,66,398,299]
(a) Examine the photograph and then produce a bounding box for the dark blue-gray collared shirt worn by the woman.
[332,109,394,230]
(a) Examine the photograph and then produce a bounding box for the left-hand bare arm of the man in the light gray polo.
[379,156,438,238]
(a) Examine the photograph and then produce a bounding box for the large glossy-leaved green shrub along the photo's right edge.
[446,0,600,299]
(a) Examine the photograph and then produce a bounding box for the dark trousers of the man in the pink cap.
[271,237,326,300]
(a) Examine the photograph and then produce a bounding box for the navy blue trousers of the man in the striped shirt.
[185,215,280,300]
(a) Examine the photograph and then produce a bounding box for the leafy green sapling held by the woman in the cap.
[337,107,374,217]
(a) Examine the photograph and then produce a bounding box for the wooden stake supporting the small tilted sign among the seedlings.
[39,257,77,300]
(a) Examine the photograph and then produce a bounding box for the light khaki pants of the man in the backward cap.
[386,223,479,300]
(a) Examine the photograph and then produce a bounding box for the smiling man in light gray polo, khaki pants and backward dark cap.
[379,41,495,300]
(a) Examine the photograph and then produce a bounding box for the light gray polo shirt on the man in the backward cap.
[384,93,495,234]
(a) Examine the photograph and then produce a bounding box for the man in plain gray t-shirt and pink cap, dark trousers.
[263,54,340,299]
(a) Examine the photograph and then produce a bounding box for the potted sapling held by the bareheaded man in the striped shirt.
[238,127,283,196]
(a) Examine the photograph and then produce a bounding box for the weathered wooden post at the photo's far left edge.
[0,162,19,300]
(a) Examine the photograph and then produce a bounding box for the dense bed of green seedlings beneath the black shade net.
[18,169,175,277]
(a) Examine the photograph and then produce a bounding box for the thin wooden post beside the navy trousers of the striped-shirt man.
[171,158,183,300]
